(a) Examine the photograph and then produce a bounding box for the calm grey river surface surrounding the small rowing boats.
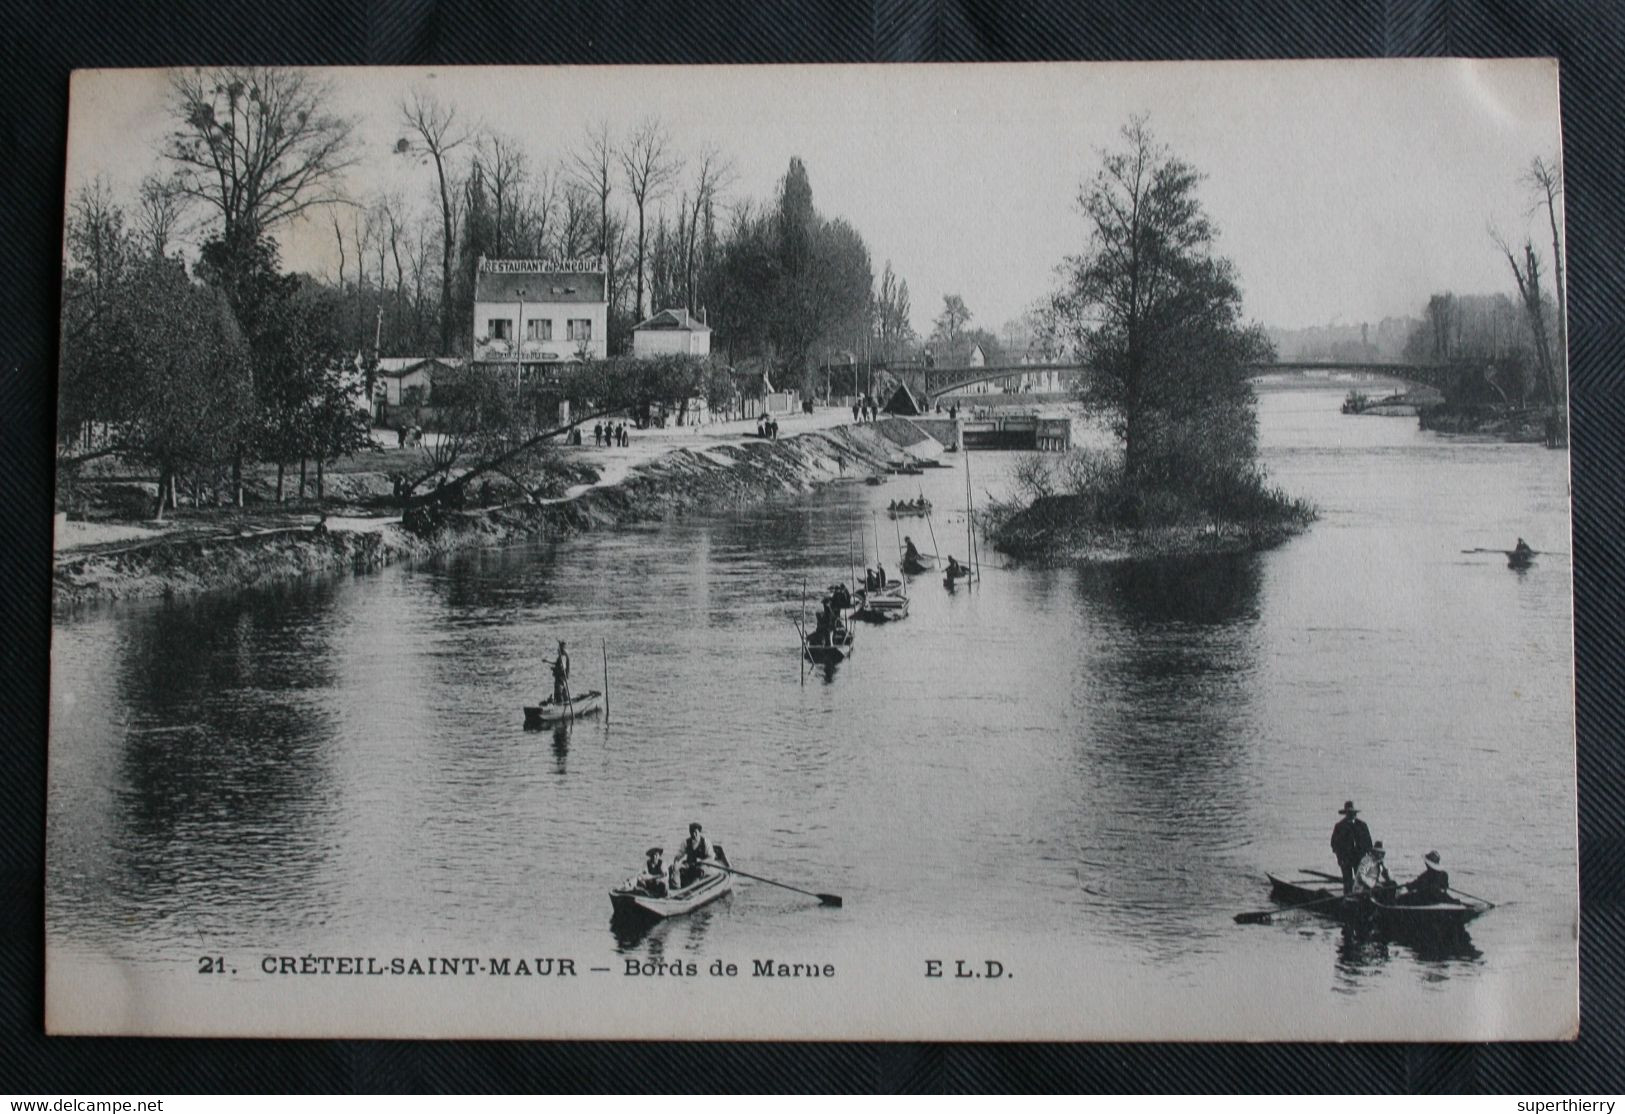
[47,386,1576,1036]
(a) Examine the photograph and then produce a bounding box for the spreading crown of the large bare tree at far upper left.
[164,67,354,250]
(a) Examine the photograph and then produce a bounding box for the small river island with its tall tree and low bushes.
[988,119,1315,560]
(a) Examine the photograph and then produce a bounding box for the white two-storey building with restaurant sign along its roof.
[473,257,609,369]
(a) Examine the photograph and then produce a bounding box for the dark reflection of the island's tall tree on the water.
[1073,554,1259,950]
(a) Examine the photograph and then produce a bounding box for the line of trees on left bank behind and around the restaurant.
[59,67,912,513]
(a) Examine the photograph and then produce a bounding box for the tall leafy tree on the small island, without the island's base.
[1050,119,1271,482]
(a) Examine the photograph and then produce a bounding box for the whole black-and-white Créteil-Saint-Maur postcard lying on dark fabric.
[46,58,1580,1041]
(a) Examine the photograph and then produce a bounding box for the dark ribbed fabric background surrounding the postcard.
[0,0,1625,1095]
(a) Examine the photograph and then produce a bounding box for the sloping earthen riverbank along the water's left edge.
[52,412,899,607]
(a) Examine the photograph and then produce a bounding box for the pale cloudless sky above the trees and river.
[67,58,1560,335]
